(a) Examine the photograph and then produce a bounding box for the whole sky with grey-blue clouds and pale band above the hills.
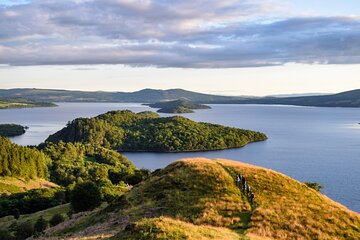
[0,0,360,96]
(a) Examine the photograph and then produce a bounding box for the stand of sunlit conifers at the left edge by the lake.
[0,137,51,178]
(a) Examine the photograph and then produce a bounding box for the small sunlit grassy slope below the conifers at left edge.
[0,177,57,194]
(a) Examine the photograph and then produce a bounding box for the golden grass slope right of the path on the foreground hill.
[217,160,360,239]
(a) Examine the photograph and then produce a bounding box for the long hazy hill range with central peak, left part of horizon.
[0,88,244,103]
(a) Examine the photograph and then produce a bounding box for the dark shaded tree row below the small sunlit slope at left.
[0,188,67,217]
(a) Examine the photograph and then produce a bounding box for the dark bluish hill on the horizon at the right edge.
[235,89,360,107]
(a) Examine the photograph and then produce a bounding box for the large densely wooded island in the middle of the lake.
[46,111,267,152]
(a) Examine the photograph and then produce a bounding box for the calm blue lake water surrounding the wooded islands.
[0,103,360,212]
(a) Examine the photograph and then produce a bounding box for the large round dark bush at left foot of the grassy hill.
[70,182,102,212]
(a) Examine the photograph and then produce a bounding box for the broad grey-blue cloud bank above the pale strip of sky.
[0,0,360,68]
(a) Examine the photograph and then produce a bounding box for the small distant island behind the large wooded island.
[145,99,211,113]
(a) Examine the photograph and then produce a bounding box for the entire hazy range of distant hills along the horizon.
[0,88,360,107]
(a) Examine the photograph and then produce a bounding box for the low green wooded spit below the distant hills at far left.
[0,96,57,109]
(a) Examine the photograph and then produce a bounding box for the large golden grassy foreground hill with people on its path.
[38,159,360,239]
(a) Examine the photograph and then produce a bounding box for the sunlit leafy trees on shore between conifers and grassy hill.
[41,141,135,186]
